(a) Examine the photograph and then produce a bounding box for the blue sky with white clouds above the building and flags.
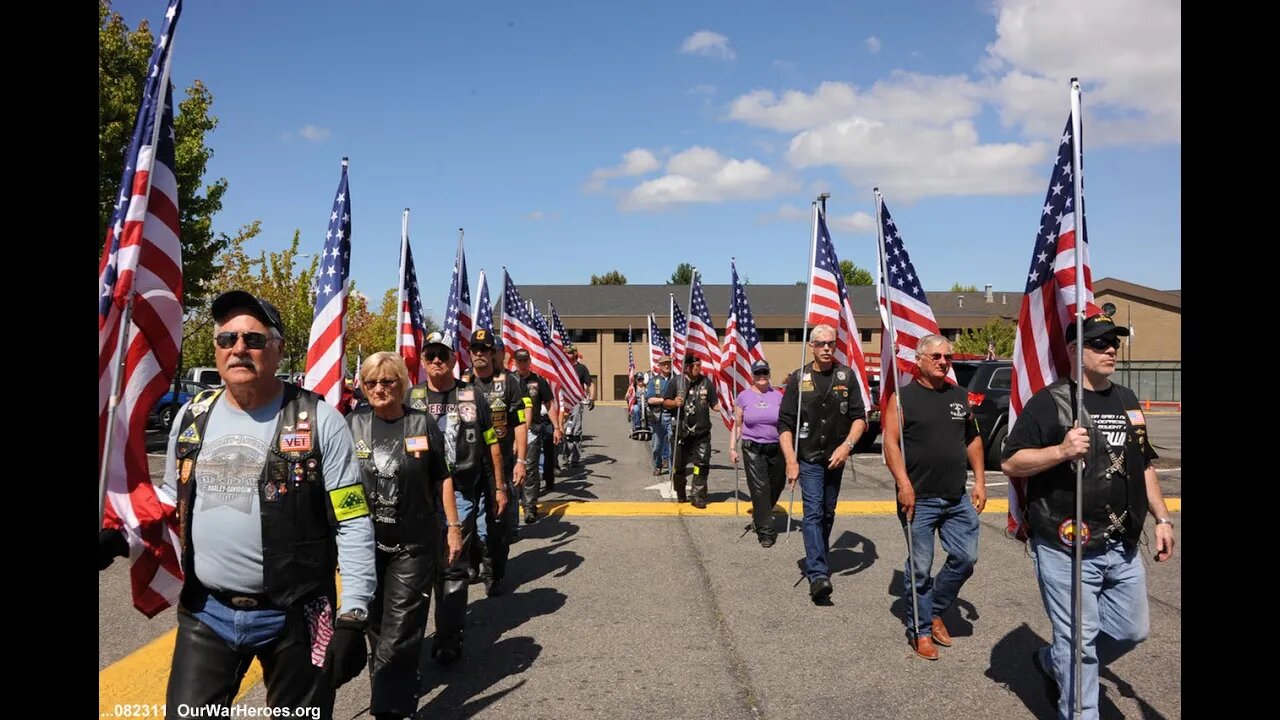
[113,0,1181,316]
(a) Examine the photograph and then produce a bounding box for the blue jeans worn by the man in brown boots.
[899,496,978,638]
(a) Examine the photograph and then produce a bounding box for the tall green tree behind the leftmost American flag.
[97,0,230,310]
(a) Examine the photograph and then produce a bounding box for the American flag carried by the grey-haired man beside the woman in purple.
[805,208,872,409]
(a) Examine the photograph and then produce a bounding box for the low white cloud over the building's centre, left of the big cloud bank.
[618,147,795,210]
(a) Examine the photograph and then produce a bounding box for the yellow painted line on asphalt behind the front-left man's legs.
[97,628,262,717]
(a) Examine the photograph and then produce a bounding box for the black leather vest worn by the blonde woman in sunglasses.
[351,407,444,552]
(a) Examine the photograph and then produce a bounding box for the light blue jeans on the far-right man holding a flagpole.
[1030,538,1151,720]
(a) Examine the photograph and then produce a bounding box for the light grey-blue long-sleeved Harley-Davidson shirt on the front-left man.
[160,388,376,612]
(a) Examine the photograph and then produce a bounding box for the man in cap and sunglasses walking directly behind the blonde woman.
[408,332,507,665]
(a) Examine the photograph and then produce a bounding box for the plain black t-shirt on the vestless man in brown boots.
[901,382,978,500]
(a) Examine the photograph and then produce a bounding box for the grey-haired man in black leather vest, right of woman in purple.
[778,325,867,605]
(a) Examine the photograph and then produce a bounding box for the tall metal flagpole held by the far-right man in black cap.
[1071,78,1085,717]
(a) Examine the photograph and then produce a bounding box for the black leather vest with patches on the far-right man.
[1027,378,1147,551]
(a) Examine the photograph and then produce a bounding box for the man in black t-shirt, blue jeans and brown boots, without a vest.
[881,334,987,660]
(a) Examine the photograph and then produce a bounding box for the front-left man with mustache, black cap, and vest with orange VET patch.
[99,291,375,717]
